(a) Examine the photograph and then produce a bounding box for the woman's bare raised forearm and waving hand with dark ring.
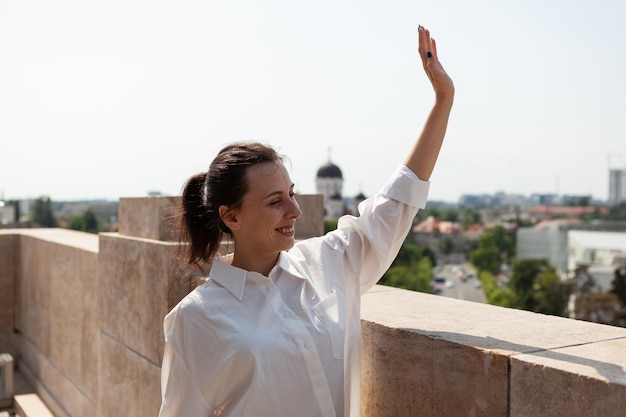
[404,26,454,181]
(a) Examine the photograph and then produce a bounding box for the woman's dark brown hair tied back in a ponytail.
[178,142,283,267]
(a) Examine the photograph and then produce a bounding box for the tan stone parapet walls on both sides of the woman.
[0,196,626,417]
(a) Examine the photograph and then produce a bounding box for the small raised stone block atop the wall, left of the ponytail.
[119,196,180,241]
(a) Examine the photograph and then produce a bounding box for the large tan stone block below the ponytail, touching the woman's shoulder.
[98,233,191,364]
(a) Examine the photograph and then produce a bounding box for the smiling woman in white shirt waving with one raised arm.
[160,26,454,417]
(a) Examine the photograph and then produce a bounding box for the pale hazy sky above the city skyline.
[0,0,626,201]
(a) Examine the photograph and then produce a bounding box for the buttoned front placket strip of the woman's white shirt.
[265,283,336,417]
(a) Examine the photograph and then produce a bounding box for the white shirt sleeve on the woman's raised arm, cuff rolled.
[337,166,430,294]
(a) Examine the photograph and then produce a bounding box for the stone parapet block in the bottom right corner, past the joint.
[510,337,626,417]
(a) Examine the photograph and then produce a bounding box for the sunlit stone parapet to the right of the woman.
[362,286,626,417]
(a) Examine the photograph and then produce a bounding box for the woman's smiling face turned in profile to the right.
[226,162,302,258]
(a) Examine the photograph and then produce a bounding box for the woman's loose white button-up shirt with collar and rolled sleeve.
[159,167,429,417]
